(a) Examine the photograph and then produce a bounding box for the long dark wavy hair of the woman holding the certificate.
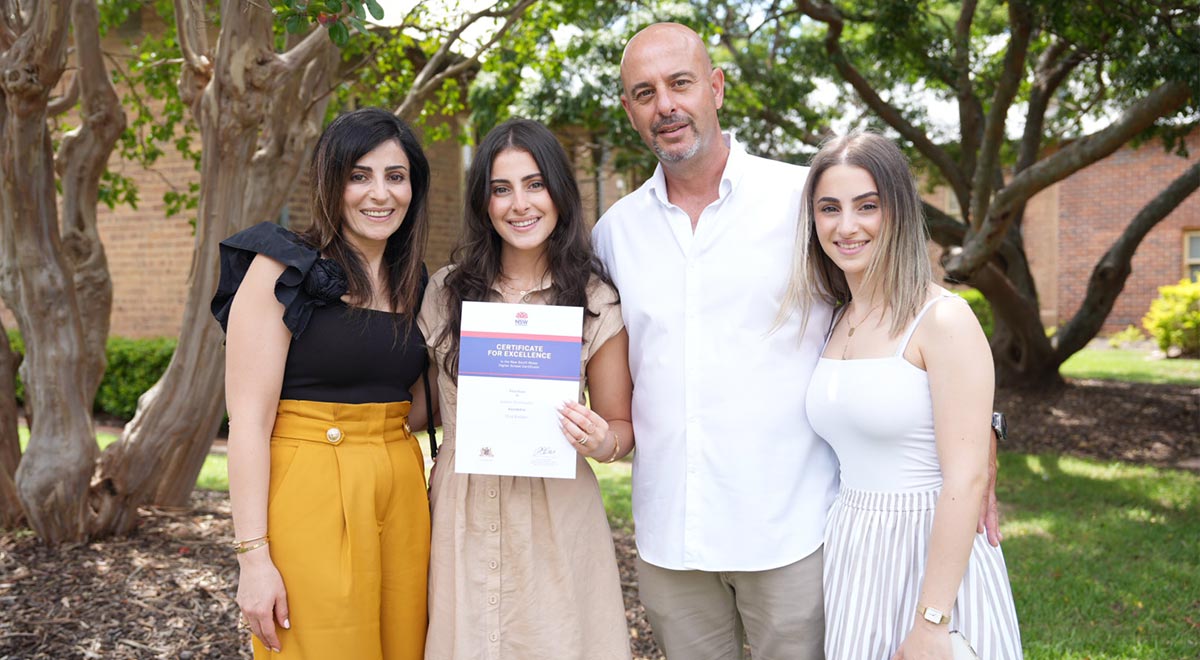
[437,119,612,378]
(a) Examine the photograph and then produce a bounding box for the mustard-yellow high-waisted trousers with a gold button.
[253,400,430,660]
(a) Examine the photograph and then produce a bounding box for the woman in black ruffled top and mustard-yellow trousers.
[212,108,430,660]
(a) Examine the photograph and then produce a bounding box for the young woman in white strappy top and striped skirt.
[786,132,1021,660]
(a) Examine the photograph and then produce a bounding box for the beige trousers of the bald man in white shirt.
[637,548,824,660]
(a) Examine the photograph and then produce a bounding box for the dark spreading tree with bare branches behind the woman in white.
[796,0,1198,388]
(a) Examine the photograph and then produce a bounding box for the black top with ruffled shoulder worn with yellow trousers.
[212,222,428,403]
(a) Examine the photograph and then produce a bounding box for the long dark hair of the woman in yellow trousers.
[301,108,430,323]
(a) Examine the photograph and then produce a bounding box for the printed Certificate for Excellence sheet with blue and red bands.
[455,302,583,479]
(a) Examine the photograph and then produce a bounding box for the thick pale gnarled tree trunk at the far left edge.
[0,0,98,545]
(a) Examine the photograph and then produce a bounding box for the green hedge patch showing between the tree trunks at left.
[95,337,175,419]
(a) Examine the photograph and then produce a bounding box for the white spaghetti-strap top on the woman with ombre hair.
[805,294,965,492]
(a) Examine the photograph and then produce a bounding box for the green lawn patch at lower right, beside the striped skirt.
[998,454,1200,660]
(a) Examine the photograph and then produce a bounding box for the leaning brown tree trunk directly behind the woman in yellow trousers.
[94,1,337,533]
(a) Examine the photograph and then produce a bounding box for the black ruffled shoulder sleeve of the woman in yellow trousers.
[212,222,346,338]
